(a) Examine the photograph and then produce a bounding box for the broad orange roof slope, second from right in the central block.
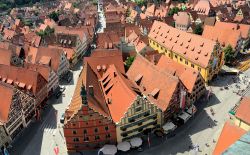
[126,54,179,111]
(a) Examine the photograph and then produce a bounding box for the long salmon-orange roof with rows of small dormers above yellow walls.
[148,21,216,68]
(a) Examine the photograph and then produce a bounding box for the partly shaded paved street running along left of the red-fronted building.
[11,63,82,155]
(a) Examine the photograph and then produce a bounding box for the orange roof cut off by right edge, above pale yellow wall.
[235,97,250,125]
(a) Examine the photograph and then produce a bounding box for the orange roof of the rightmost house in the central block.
[156,55,200,93]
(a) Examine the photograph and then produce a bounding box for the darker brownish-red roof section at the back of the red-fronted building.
[84,49,125,78]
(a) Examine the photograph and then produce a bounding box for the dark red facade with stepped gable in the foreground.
[64,106,116,151]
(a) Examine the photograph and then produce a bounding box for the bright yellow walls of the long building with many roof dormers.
[149,38,223,83]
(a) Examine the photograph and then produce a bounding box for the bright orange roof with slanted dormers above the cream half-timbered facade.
[100,65,139,123]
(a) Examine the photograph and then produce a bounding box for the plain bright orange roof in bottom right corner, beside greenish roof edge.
[213,122,246,155]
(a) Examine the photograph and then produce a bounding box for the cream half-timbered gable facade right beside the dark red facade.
[116,96,162,142]
